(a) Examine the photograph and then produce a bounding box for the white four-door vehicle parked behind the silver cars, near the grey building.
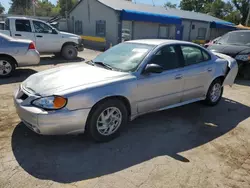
[0,17,84,59]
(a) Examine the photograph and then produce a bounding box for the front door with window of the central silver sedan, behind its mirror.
[137,45,183,114]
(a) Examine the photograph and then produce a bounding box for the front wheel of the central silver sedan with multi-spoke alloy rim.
[87,99,128,142]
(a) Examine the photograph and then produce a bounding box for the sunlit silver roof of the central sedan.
[127,39,194,46]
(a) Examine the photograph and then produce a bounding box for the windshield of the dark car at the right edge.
[216,31,250,45]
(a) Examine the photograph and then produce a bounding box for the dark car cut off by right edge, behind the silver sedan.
[208,30,250,79]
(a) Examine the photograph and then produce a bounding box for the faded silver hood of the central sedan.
[22,63,129,96]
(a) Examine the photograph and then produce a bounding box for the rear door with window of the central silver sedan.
[181,45,215,102]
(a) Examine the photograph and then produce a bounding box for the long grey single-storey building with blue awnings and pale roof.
[69,0,236,45]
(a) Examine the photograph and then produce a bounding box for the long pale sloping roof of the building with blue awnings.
[98,0,231,22]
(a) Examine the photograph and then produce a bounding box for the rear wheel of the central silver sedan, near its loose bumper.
[204,79,224,106]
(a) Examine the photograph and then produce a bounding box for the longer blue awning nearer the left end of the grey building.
[121,10,181,24]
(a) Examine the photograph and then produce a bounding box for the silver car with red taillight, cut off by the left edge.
[0,33,40,77]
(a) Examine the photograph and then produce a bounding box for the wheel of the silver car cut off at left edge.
[0,57,16,78]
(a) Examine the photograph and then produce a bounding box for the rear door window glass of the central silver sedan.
[181,46,210,66]
